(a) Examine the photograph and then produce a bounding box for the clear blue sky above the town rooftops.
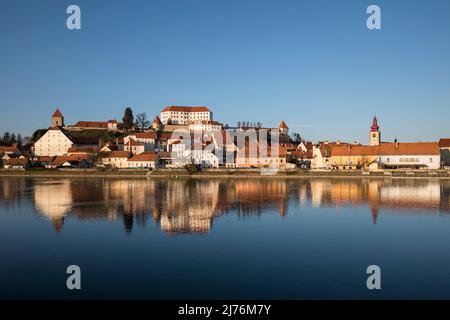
[0,0,450,143]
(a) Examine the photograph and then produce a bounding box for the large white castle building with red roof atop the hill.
[161,106,213,125]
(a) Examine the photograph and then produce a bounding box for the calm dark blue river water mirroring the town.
[0,178,450,299]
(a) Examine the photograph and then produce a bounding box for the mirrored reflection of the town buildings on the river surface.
[0,178,450,233]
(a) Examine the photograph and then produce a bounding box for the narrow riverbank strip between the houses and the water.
[0,169,450,179]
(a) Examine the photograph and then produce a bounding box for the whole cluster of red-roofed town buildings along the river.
[0,106,450,170]
